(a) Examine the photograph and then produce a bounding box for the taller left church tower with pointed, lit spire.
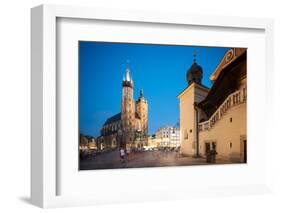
[121,64,135,148]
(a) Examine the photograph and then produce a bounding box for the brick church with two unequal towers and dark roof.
[98,65,148,149]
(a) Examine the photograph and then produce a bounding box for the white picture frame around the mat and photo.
[31,5,273,208]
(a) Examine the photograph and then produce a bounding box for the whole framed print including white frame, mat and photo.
[31,5,273,207]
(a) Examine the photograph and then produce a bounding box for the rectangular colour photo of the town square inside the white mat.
[77,41,247,170]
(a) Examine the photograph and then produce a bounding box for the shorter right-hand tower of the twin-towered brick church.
[136,89,148,136]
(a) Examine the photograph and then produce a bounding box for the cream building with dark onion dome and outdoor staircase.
[178,48,247,162]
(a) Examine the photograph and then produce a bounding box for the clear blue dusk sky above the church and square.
[79,41,229,137]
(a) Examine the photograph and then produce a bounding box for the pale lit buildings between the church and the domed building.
[155,126,180,148]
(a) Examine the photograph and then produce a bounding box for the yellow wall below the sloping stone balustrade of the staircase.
[199,103,247,162]
